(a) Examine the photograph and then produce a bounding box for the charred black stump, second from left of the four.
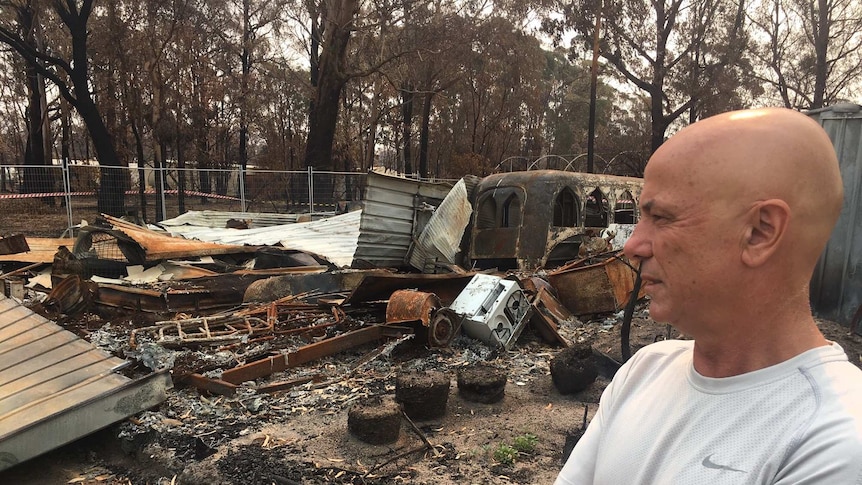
[395,371,449,421]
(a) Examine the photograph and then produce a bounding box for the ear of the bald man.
[742,199,790,267]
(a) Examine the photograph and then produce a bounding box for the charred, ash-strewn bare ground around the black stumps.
[0,309,862,485]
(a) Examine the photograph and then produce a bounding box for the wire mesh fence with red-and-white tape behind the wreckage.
[0,164,365,237]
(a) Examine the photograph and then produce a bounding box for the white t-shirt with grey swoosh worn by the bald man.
[556,340,862,485]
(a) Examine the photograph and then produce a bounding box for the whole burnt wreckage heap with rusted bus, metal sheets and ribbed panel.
[0,170,642,470]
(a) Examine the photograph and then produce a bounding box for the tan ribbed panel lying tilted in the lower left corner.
[0,294,172,470]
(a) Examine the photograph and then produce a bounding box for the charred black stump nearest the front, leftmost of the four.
[347,397,401,445]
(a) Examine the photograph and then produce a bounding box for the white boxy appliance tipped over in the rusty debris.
[449,274,531,350]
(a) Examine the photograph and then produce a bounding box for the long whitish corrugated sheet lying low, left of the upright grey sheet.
[161,211,362,266]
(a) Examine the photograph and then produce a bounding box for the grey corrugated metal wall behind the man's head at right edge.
[809,104,862,325]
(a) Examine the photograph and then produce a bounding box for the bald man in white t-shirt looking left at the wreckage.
[556,108,862,485]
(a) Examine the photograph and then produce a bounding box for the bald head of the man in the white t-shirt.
[625,108,843,336]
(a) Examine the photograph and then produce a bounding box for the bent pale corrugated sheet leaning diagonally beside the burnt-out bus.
[410,179,473,270]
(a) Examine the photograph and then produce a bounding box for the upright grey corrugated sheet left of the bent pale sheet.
[354,173,452,268]
